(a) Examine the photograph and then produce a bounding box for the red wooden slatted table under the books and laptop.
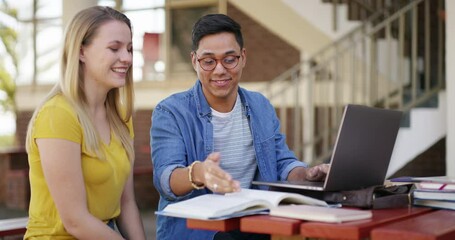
[187,207,455,240]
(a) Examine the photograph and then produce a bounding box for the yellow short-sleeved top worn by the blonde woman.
[24,95,133,239]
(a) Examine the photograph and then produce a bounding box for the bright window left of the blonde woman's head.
[6,0,62,85]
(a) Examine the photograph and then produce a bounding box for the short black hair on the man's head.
[191,14,243,51]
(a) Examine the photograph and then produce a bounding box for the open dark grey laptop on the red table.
[253,104,402,191]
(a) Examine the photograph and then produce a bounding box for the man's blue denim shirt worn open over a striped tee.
[150,80,307,240]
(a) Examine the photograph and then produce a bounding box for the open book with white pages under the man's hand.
[156,189,328,220]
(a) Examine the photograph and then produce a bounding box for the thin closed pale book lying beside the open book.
[270,205,373,223]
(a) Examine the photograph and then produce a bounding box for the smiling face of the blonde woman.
[79,20,133,92]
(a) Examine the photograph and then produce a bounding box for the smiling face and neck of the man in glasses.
[191,32,246,112]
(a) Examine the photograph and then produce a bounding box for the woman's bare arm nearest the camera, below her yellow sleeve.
[36,138,123,239]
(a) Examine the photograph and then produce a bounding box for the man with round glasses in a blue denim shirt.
[151,14,327,240]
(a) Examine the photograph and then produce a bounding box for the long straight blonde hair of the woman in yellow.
[26,6,134,161]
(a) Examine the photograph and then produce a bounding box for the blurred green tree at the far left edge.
[0,0,18,114]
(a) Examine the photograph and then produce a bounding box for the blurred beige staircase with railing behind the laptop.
[262,0,446,175]
